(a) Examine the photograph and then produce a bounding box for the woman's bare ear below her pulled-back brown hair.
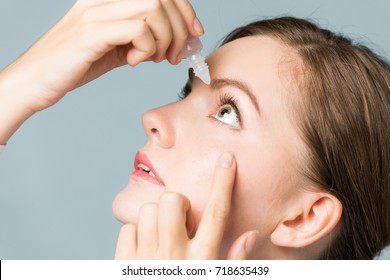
[271,192,342,248]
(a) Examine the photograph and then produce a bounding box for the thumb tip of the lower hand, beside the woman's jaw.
[226,230,259,260]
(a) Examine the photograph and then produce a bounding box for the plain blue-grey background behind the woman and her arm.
[0,0,390,259]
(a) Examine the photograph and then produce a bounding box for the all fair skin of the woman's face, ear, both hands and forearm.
[0,0,342,259]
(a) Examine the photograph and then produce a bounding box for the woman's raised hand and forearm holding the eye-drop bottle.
[0,0,203,144]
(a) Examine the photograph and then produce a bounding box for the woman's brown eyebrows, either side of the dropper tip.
[188,69,261,115]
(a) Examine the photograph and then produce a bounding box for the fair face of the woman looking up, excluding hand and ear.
[113,36,302,254]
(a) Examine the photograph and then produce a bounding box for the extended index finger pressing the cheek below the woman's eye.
[194,152,236,257]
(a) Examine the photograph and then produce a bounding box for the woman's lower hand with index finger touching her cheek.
[115,153,258,259]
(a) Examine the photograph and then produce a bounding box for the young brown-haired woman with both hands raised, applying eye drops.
[0,0,390,259]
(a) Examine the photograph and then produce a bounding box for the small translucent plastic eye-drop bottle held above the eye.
[182,36,211,85]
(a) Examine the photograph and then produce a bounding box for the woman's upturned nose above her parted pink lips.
[142,105,175,148]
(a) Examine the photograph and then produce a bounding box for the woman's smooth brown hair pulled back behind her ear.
[222,17,390,259]
